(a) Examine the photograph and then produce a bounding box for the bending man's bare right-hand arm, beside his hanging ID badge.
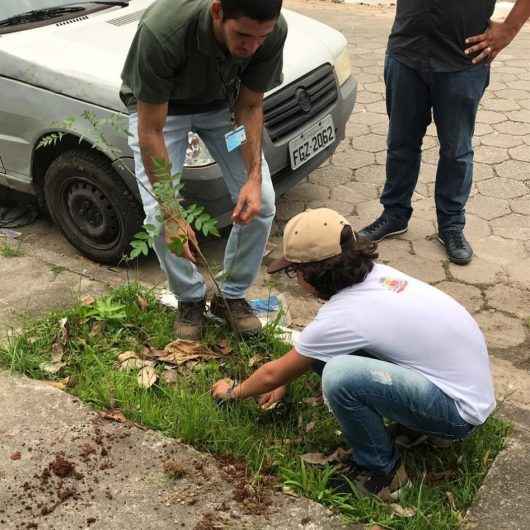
[232,85,263,224]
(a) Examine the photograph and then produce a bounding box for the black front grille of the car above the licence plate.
[263,64,338,142]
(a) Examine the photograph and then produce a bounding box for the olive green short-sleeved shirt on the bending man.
[120,0,287,114]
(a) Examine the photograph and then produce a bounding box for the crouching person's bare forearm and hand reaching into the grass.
[212,348,313,399]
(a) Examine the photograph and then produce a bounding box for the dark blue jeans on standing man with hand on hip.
[381,56,490,231]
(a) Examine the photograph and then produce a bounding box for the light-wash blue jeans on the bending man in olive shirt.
[129,109,276,302]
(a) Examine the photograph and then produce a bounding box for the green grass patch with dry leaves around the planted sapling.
[0,284,509,530]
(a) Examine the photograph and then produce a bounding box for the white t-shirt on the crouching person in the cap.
[295,263,495,425]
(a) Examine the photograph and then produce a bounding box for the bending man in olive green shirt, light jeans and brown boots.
[120,0,287,339]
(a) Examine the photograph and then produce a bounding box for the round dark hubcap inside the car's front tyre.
[65,179,120,246]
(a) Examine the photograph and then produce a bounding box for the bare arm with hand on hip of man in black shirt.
[465,0,530,64]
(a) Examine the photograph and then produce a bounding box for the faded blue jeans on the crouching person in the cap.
[322,355,474,473]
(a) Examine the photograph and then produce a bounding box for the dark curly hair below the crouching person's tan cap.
[296,225,379,300]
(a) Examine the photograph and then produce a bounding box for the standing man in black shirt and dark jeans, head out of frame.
[360,0,530,265]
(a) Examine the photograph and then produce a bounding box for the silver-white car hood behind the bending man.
[0,0,346,112]
